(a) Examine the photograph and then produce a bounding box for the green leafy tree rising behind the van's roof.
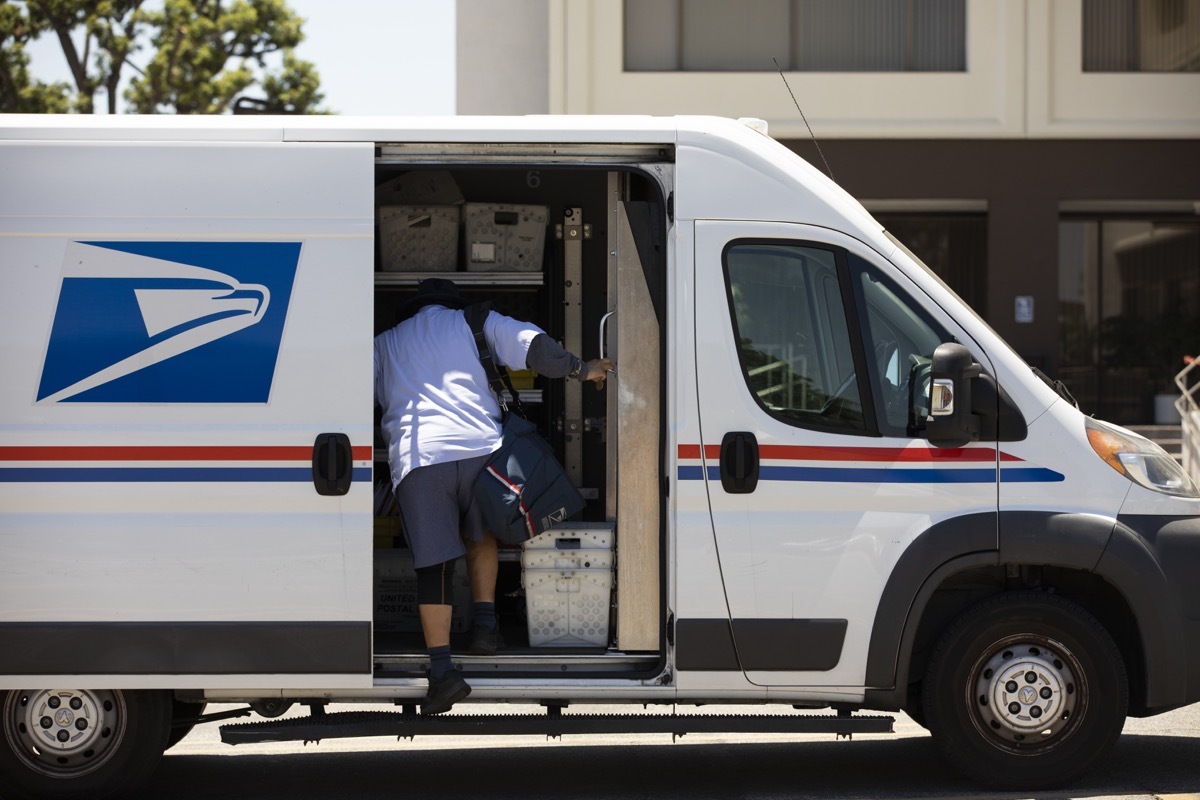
[0,0,323,114]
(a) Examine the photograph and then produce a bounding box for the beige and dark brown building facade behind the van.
[457,0,1200,423]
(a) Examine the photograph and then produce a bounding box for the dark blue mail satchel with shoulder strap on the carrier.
[466,303,586,545]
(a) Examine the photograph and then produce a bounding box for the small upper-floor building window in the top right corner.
[1084,0,1200,72]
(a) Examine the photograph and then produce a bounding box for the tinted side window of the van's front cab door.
[725,241,953,437]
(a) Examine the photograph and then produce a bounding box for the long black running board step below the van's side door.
[221,709,894,745]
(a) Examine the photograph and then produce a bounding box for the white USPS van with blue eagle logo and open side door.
[0,115,1200,798]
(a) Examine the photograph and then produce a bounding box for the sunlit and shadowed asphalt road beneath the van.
[131,705,1200,800]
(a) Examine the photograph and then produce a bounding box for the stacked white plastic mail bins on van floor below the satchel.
[521,523,616,648]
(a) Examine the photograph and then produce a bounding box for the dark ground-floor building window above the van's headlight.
[1058,216,1200,425]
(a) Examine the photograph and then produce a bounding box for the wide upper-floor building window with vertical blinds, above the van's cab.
[624,0,966,72]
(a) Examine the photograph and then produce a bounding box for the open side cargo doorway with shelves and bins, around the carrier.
[364,145,670,682]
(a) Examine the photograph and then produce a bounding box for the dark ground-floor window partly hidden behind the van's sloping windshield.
[874,211,988,315]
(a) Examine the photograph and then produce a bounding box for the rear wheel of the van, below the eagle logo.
[0,688,172,800]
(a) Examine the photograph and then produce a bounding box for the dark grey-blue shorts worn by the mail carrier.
[396,455,490,569]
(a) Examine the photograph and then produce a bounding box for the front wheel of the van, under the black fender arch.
[923,593,1129,789]
